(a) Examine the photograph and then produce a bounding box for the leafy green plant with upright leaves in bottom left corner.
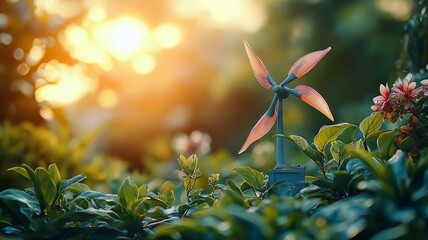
[0,164,86,239]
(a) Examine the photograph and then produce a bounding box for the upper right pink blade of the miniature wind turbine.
[288,47,331,77]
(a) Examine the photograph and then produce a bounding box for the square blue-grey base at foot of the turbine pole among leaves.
[269,165,305,197]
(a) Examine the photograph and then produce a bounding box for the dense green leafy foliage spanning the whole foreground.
[0,144,428,239]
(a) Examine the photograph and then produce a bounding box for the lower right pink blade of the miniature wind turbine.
[294,85,334,121]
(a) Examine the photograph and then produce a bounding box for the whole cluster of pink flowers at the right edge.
[371,74,428,121]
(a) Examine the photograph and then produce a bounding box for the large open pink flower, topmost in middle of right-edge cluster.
[392,74,422,110]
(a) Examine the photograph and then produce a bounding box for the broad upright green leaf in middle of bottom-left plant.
[34,167,57,208]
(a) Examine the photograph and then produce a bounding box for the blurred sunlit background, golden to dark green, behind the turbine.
[0,0,414,170]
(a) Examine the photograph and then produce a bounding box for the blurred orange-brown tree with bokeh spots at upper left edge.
[0,0,81,124]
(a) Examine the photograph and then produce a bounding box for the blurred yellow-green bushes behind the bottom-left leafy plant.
[0,122,128,190]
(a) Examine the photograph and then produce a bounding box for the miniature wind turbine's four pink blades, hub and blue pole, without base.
[239,40,334,169]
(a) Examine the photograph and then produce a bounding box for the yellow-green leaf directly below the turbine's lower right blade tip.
[314,123,356,153]
